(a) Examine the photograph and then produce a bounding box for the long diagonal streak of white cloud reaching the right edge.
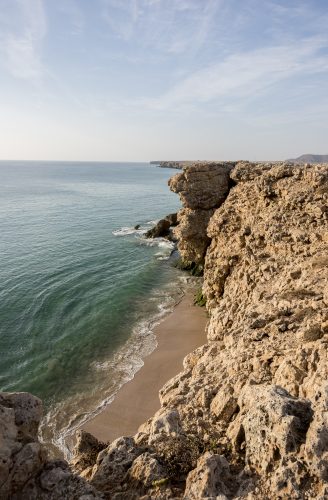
[138,37,328,110]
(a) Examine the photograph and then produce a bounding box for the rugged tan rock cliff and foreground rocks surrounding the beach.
[0,162,328,500]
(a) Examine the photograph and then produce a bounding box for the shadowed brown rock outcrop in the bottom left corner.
[0,393,103,500]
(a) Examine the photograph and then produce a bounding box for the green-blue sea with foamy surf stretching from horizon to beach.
[0,161,186,456]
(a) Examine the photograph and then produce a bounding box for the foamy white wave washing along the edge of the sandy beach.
[40,279,184,460]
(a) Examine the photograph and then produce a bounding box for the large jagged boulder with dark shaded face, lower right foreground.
[228,385,313,473]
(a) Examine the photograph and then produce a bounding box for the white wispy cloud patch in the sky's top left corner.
[0,0,47,81]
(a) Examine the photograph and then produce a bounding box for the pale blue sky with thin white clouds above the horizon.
[0,0,328,161]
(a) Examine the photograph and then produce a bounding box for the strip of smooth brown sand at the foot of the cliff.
[82,291,207,442]
